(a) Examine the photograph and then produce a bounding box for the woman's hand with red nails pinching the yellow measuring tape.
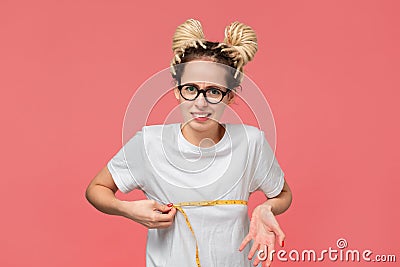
[122,199,176,229]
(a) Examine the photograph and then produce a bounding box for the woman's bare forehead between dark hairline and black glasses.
[181,61,230,86]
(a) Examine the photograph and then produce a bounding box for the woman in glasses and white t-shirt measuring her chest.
[86,19,291,266]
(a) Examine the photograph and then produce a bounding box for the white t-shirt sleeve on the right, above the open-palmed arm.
[249,131,285,198]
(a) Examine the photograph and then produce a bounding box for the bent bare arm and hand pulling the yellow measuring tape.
[86,166,176,228]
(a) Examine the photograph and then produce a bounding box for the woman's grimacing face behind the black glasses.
[174,60,234,134]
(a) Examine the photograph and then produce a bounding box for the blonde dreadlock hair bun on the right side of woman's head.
[222,21,258,76]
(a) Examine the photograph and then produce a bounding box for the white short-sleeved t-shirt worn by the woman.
[107,123,284,267]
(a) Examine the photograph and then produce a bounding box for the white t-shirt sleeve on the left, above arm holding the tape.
[107,131,144,193]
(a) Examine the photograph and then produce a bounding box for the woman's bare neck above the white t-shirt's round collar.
[181,123,225,147]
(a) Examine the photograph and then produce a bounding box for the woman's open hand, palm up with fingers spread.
[239,203,285,266]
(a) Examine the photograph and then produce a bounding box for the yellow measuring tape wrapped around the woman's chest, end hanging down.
[173,200,247,267]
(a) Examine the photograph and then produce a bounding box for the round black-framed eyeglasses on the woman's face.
[178,83,230,104]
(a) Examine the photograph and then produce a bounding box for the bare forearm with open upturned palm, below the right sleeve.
[239,181,292,266]
